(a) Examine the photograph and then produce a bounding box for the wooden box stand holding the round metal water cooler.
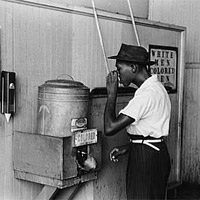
[13,132,101,189]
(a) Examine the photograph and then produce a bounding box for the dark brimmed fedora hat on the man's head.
[108,44,155,65]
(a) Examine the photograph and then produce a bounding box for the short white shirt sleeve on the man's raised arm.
[119,92,152,124]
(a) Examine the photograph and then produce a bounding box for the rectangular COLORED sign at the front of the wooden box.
[74,129,97,147]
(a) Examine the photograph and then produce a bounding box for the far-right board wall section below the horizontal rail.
[182,64,200,184]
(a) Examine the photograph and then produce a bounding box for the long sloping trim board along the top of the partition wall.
[1,0,186,32]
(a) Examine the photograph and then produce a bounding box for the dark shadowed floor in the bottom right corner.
[167,184,200,200]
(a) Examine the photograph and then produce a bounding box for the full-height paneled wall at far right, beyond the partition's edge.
[149,0,200,183]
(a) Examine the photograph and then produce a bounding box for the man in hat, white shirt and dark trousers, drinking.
[104,44,171,200]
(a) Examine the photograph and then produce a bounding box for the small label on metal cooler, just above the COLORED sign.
[71,117,87,132]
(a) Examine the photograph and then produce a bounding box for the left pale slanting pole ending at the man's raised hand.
[91,0,110,73]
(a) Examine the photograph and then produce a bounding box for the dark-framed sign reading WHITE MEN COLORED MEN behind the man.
[149,45,178,93]
